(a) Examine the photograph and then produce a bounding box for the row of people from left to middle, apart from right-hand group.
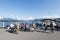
[7,22,35,33]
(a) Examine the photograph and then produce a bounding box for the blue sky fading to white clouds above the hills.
[0,0,60,19]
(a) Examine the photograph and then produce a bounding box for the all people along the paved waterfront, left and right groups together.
[7,21,59,33]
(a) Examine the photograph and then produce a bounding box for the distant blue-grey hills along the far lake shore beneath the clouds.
[0,18,60,22]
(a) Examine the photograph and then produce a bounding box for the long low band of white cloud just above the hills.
[9,14,60,20]
